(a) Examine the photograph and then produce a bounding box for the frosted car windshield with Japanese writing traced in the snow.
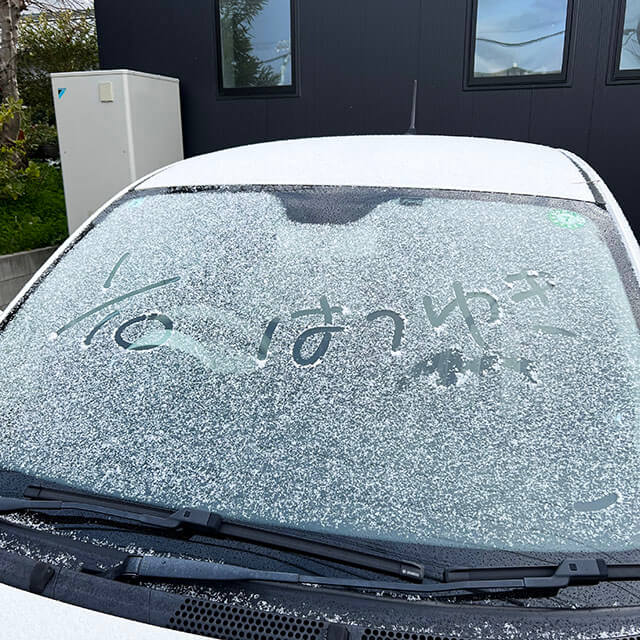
[0,187,640,551]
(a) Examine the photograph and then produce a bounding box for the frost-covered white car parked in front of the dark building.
[0,137,640,640]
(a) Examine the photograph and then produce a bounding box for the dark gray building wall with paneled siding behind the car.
[95,0,640,229]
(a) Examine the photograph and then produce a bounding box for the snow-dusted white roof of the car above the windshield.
[137,135,594,202]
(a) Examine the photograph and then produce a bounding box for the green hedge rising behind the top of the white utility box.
[18,11,99,125]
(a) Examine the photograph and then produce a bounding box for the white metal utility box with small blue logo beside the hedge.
[51,70,184,232]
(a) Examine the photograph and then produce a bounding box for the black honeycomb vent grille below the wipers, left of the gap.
[167,598,329,640]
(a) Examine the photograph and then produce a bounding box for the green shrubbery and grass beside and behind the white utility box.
[0,11,87,254]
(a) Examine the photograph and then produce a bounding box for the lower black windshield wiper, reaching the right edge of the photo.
[94,555,640,595]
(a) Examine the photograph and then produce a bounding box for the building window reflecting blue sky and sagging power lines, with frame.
[467,0,572,86]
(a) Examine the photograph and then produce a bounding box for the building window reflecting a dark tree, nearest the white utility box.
[216,0,296,96]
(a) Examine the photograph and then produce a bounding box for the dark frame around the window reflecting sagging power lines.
[463,0,577,90]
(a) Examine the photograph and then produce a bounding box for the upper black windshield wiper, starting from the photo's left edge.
[0,485,424,582]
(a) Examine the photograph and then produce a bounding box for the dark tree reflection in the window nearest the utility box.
[220,0,279,87]
